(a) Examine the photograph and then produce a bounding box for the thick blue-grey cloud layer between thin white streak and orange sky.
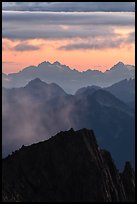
[2,11,135,40]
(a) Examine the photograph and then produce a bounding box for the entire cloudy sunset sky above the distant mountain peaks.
[2,2,135,73]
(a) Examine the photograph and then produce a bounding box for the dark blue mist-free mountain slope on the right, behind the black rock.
[71,90,135,168]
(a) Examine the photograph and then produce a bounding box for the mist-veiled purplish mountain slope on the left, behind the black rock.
[2,79,67,156]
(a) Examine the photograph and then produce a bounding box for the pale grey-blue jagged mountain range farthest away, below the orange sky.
[2,62,135,94]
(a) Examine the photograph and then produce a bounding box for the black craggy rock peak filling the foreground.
[2,129,135,202]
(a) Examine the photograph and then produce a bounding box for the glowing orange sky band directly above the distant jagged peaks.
[2,37,135,73]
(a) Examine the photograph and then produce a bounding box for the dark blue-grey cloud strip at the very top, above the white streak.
[2,2,135,12]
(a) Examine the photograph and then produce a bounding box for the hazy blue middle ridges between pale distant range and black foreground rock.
[2,79,135,168]
